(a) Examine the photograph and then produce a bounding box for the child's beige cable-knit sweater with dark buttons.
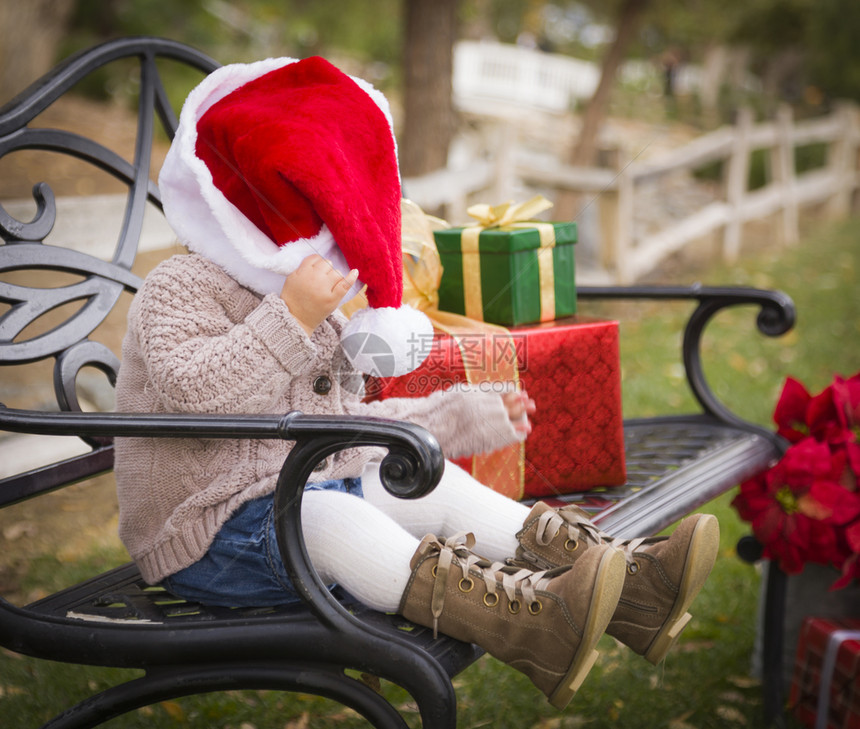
[116,254,519,583]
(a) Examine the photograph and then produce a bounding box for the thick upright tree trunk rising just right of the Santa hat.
[400,0,459,177]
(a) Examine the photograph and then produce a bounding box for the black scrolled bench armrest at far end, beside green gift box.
[577,284,796,432]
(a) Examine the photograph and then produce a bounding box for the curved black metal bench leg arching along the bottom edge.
[42,663,414,729]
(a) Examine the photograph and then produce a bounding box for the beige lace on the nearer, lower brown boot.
[430,532,558,638]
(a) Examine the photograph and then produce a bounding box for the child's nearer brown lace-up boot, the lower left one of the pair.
[400,535,625,709]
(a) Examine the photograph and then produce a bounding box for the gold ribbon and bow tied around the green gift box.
[460,195,555,321]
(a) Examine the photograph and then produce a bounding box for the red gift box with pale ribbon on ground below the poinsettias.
[788,617,860,729]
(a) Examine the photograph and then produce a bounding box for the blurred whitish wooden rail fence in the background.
[404,104,860,283]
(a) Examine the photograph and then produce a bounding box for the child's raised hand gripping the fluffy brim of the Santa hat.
[281,255,358,336]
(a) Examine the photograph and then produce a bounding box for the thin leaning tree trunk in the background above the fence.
[570,0,649,165]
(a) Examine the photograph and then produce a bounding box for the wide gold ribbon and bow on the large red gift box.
[342,200,524,500]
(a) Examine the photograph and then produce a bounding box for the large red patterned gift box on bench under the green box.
[369,316,626,498]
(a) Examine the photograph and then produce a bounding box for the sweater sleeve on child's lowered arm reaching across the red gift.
[344,385,525,458]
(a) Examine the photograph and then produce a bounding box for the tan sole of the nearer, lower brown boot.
[549,549,627,710]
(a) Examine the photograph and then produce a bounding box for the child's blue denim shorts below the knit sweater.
[162,478,362,607]
